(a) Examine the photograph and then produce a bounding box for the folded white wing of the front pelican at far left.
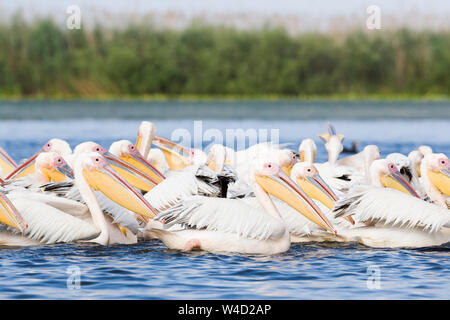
[11,198,100,244]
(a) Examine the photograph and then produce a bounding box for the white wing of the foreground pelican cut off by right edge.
[333,187,450,232]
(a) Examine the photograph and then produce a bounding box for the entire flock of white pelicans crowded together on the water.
[0,121,450,254]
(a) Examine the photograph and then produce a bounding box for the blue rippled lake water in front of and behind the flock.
[0,102,450,299]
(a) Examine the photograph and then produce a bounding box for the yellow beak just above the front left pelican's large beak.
[103,152,157,192]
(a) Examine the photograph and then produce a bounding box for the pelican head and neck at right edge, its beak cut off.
[420,153,450,209]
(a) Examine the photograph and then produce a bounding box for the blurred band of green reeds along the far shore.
[0,16,450,98]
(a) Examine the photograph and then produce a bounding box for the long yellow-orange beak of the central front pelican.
[255,170,336,234]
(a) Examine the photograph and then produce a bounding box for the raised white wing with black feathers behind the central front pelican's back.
[144,166,221,211]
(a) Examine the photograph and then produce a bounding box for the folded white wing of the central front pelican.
[155,196,286,240]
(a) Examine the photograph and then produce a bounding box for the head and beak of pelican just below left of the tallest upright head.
[109,140,165,183]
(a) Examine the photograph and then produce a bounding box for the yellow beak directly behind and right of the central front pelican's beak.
[296,174,355,224]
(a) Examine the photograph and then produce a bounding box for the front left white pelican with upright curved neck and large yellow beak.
[0,153,155,245]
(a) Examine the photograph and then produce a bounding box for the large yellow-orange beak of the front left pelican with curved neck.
[83,164,157,219]
